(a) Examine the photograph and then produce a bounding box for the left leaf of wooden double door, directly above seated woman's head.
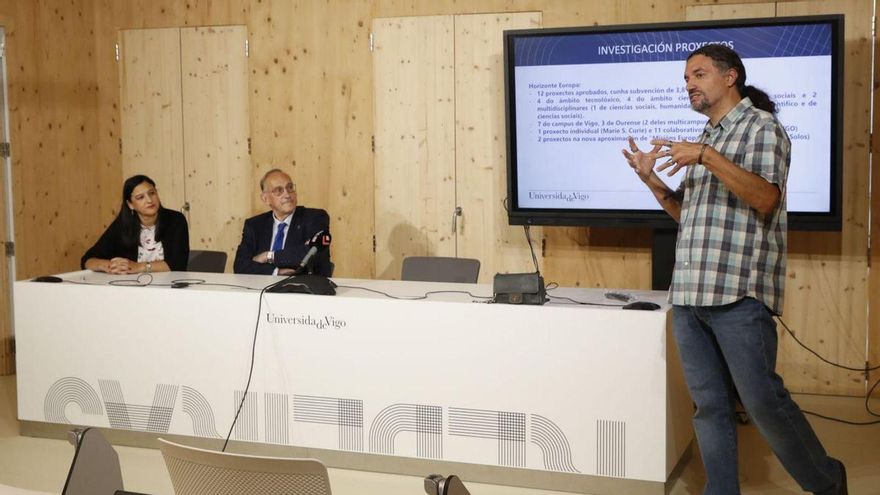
[119,28,186,210]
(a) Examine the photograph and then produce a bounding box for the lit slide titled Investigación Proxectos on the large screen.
[513,24,833,212]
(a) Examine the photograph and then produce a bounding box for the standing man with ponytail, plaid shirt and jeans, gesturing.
[623,44,847,495]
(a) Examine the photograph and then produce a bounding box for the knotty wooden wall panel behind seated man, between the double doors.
[249,0,374,278]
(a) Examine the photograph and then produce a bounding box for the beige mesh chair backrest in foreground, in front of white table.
[159,438,330,495]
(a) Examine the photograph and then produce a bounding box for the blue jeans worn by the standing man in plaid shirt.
[673,298,841,495]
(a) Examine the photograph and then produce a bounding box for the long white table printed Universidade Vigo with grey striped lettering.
[14,271,693,493]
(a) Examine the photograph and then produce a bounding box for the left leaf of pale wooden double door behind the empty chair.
[373,16,455,279]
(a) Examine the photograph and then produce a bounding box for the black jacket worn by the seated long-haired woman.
[80,208,189,272]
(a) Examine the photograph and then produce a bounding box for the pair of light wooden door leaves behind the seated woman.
[119,26,248,270]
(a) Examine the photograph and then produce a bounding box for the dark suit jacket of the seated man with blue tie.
[233,206,330,277]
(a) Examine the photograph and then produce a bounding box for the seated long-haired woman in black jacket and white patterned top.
[80,175,189,274]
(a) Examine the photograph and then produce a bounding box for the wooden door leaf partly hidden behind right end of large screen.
[777,0,872,395]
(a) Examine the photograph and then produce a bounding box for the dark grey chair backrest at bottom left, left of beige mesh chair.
[61,428,122,495]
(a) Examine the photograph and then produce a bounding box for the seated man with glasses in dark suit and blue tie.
[233,168,332,277]
